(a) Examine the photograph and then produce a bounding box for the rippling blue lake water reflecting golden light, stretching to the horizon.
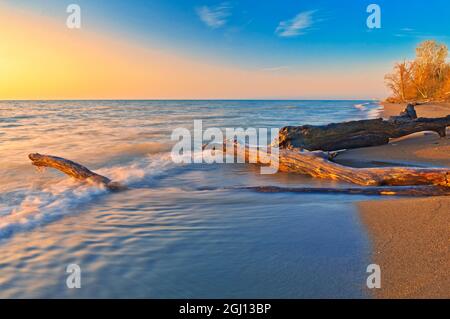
[0,101,379,298]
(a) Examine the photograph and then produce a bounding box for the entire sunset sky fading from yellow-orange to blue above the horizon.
[0,0,450,100]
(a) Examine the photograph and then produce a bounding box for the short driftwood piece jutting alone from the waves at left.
[28,153,125,191]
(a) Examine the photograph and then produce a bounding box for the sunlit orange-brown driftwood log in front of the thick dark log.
[216,143,450,196]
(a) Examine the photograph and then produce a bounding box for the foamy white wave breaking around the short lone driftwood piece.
[0,152,179,240]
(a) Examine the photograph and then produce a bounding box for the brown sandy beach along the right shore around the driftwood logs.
[354,103,450,298]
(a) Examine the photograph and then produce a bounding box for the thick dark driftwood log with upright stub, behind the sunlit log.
[279,104,450,151]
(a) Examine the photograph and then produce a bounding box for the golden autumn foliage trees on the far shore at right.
[385,41,450,102]
